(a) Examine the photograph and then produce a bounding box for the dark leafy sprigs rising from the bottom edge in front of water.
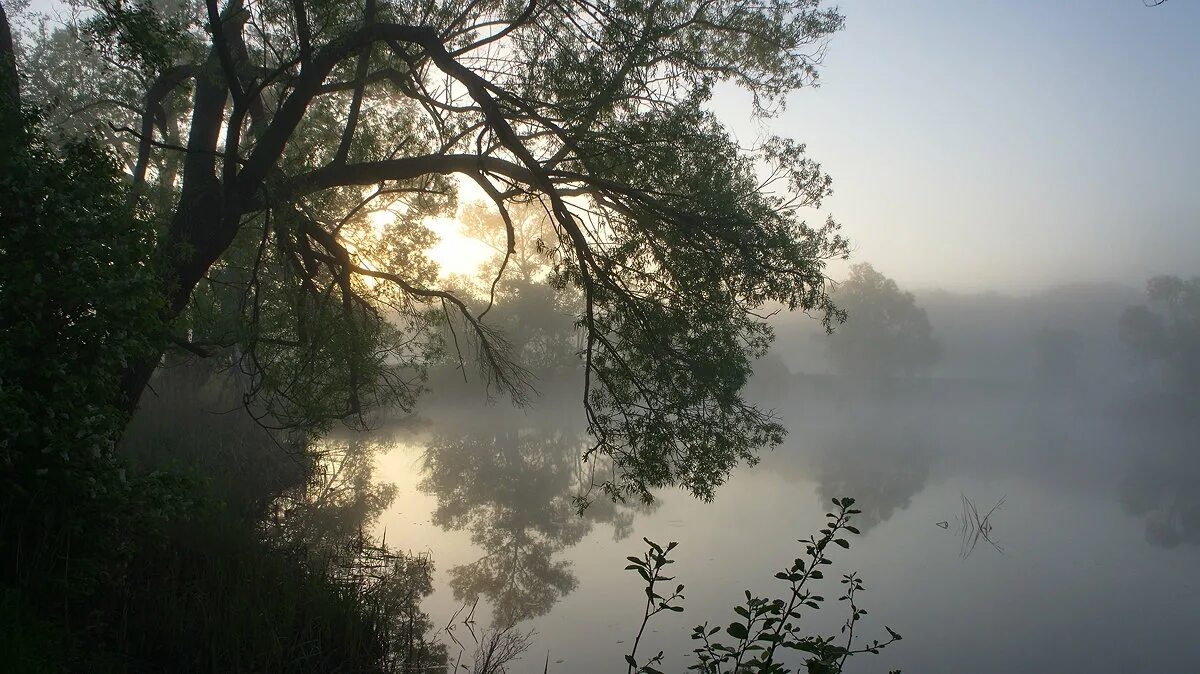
[625,498,901,674]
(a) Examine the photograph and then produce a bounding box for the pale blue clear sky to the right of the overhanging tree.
[714,0,1200,293]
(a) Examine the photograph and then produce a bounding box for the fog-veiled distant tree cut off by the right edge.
[1120,276,1200,387]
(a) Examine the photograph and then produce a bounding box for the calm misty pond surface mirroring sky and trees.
[355,381,1200,673]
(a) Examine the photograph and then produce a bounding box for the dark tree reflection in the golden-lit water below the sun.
[420,419,650,628]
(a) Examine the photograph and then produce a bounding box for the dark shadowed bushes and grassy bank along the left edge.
[0,102,440,672]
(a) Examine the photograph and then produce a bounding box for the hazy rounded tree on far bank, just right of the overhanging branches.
[829,263,941,377]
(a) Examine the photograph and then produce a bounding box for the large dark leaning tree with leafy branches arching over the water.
[20,0,846,497]
